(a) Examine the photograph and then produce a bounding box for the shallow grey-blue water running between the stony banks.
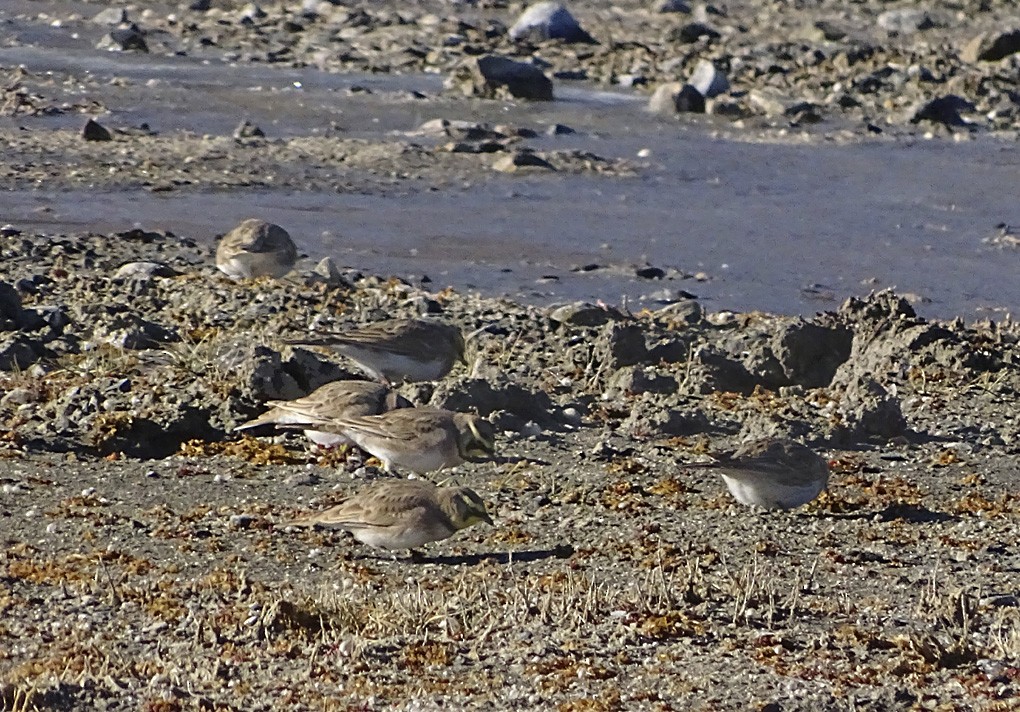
[0,40,1020,318]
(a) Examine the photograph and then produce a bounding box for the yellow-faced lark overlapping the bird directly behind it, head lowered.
[289,408,496,474]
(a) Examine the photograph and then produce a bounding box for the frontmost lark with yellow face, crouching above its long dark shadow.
[287,479,493,549]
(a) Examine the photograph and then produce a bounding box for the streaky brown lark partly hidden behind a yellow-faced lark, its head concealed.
[234,380,411,448]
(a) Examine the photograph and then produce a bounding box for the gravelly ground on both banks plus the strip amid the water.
[0,1,1020,711]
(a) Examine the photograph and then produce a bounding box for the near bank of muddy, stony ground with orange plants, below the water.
[0,228,1020,710]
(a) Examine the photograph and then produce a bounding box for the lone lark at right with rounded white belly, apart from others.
[695,438,828,509]
